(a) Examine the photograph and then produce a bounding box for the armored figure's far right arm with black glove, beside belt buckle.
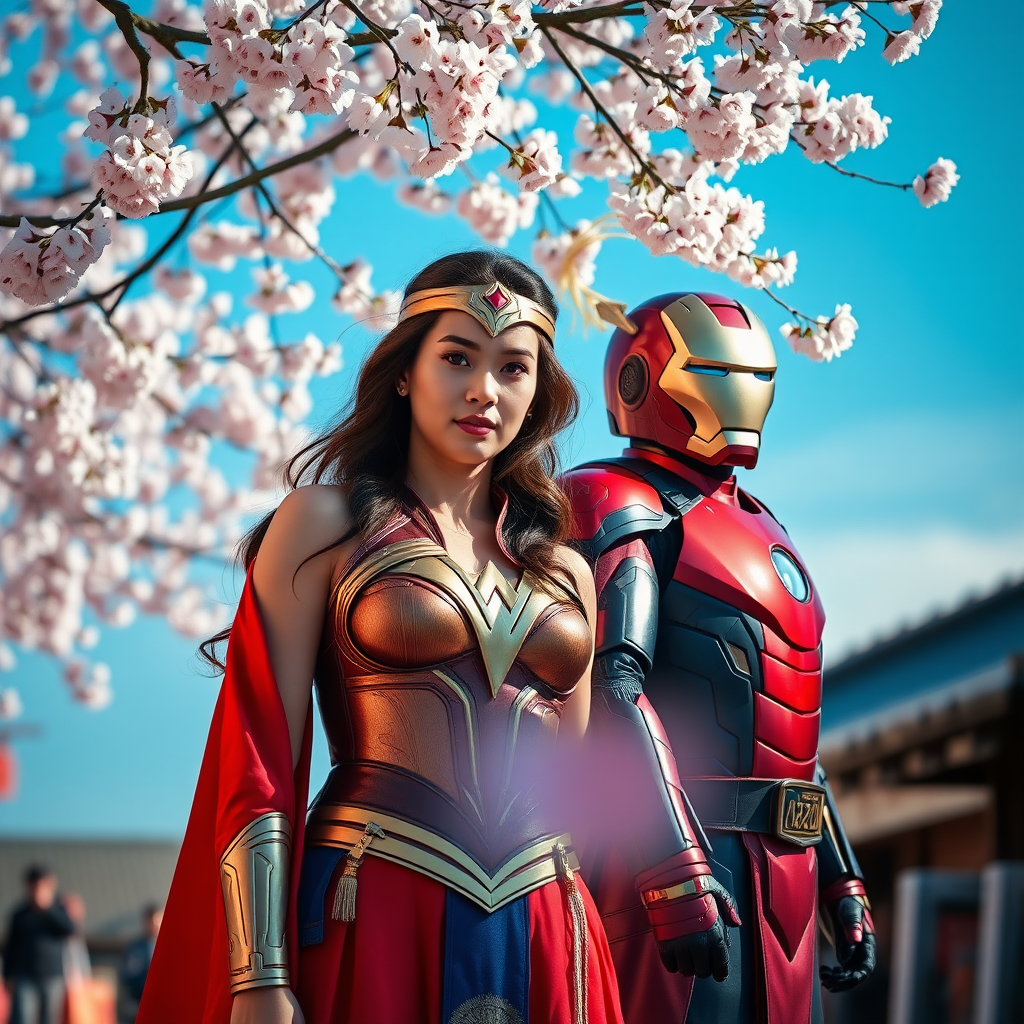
[814,765,876,992]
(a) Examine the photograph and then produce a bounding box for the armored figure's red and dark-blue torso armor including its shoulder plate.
[571,449,824,781]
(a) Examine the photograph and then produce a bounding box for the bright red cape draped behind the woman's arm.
[136,573,312,1024]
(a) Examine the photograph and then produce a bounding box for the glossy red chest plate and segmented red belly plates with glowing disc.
[673,486,824,780]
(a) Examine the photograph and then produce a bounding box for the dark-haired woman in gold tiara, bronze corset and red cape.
[139,252,621,1024]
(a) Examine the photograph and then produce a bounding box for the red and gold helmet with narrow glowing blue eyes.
[604,292,776,468]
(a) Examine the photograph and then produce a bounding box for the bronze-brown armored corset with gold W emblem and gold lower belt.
[307,509,591,910]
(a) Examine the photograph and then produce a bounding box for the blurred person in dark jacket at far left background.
[3,864,76,1024]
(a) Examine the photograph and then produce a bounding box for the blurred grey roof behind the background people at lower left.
[0,839,179,942]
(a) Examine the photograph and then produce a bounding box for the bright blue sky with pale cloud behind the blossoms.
[0,4,1024,836]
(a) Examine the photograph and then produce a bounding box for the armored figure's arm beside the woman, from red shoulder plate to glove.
[566,468,739,979]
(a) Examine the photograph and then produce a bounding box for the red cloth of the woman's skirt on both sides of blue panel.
[295,856,623,1024]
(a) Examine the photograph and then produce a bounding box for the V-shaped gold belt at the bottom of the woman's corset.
[306,804,580,911]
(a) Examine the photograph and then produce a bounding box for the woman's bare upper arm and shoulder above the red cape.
[253,484,351,764]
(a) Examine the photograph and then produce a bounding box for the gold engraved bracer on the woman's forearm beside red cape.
[220,811,292,993]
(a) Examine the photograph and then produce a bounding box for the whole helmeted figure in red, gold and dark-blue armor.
[564,294,874,1024]
